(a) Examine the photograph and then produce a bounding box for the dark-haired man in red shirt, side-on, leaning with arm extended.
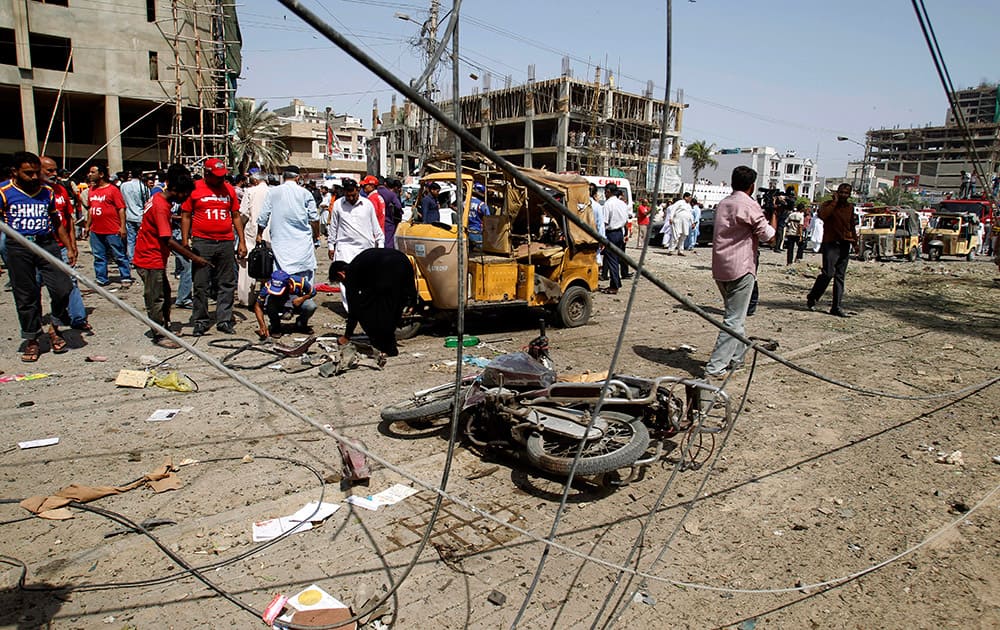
[132,164,208,349]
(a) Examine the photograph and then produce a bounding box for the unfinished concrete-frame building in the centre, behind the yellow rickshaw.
[374,69,683,191]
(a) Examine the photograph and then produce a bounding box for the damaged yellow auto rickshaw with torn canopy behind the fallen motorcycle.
[396,169,598,338]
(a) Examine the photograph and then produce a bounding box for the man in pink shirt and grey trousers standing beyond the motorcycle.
[705,166,774,378]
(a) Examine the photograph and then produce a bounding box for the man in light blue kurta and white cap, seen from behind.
[257,167,319,281]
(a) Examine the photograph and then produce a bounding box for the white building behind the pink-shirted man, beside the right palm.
[681,147,819,200]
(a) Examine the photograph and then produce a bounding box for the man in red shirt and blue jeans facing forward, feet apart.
[84,162,132,288]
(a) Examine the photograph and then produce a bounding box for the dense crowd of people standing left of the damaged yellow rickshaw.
[0,152,416,362]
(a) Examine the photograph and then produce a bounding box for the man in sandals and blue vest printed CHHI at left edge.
[0,151,77,363]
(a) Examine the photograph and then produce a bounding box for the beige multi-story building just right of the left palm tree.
[273,99,371,177]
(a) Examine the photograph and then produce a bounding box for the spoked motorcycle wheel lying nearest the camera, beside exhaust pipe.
[526,411,649,477]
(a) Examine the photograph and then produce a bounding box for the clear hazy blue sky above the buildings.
[237,0,1000,177]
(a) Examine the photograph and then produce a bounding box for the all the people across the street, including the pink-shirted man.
[0,152,996,379]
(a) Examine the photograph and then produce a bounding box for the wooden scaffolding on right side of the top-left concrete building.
[161,0,242,166]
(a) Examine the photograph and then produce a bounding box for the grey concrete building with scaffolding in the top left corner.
[0,0,241,171]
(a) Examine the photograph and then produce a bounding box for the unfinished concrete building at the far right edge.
[866,85,1000,193]
